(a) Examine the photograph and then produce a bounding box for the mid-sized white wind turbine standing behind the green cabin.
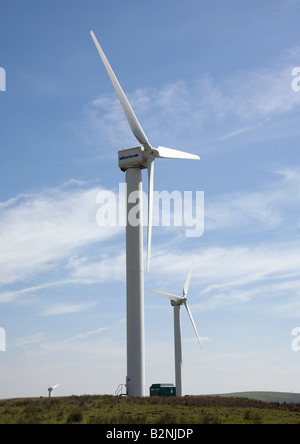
[153,264,202,396]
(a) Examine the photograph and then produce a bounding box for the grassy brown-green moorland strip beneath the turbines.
[0,396,300,425]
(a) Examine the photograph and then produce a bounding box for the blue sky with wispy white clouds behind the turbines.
[0,0,300,398]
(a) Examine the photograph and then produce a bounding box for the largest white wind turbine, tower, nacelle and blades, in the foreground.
[91,31,200,397]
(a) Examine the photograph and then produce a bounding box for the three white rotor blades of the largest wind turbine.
[91,31,200,271]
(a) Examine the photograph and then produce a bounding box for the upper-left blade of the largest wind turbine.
[91,31,151,149]
